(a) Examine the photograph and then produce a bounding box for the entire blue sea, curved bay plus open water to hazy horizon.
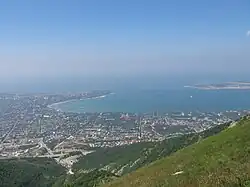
[0,73,250,113]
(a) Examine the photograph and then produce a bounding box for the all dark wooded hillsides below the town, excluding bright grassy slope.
[0,120,230,187]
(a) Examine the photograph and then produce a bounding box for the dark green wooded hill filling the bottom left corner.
[0,158,65,187]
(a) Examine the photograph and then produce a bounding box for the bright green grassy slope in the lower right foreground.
[106,118,250,187]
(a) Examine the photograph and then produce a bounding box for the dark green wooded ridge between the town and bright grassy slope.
[73,123,230,175]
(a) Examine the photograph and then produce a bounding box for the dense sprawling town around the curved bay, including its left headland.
[0,91,248,168]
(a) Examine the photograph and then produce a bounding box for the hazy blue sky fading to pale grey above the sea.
[0,0,250,79]
